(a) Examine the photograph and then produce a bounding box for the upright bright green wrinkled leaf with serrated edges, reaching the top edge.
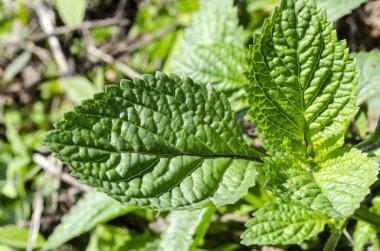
[247,0,358,158]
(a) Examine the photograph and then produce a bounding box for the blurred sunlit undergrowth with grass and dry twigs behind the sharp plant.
[0,0,380,251]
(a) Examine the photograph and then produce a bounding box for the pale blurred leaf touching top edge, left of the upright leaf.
[183,0,244,48]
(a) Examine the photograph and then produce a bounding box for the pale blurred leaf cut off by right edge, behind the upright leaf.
[351,51,380,115]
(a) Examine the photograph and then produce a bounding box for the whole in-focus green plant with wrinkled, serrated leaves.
[43,0,378,250]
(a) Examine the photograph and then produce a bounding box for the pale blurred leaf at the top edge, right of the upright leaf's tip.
[316,0,368,21]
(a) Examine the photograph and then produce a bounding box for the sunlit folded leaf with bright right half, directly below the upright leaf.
[265,149,378,218]
